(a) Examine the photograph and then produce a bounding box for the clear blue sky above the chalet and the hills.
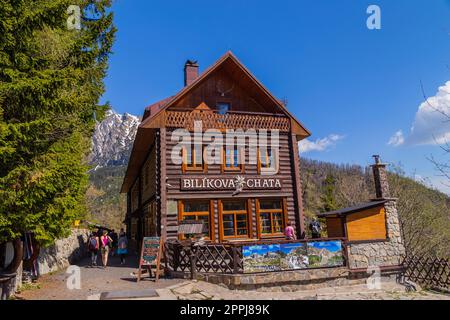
[103,0,450,190]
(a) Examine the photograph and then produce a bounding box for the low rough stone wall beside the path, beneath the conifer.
[37,229,89,275]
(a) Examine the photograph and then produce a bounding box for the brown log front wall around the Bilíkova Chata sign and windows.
[163,130,302,241]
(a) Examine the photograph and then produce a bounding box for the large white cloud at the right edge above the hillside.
[389,81,450,146]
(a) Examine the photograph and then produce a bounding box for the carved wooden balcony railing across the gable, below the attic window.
[165,111,291,132]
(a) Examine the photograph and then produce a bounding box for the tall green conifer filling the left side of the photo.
[0,0,115,244]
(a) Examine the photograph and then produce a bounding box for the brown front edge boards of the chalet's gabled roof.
[140,51,311,140]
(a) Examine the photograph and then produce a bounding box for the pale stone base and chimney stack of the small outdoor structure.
[348,200,405,269]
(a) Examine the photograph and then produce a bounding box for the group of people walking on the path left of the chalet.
[88,229,128,268]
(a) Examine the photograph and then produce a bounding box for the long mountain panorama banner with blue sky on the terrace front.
[242,241,344,273]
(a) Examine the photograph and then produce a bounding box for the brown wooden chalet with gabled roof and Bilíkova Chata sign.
[121,52,310,243]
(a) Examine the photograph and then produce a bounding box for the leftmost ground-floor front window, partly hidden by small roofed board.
[179,200,212,239]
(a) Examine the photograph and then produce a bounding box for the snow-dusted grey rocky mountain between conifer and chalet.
[89,110,141,168]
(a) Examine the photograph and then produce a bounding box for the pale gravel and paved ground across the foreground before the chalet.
[16,257,450,300]
